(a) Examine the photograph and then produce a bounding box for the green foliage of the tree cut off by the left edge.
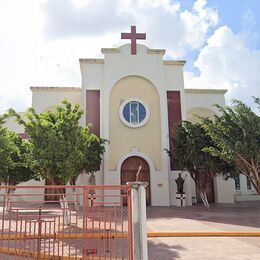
[0,115,33,185]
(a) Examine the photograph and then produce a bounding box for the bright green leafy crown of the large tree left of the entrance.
[9,101,104,185]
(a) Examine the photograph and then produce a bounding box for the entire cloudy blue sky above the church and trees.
[0,0,260,113]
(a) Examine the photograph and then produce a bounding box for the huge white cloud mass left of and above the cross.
[0,0,218,112]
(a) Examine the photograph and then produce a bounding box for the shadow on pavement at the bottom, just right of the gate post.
[148,238,186,260]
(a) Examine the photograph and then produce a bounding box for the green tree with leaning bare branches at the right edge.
[203,98,260,194]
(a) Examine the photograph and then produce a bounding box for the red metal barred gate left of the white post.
[0,185,133,260]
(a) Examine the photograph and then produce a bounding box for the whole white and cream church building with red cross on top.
[7,26,256,206]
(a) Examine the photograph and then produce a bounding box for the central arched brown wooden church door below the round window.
[121,156,151,205]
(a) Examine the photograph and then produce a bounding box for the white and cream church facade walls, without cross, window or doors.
[4,44,258,206]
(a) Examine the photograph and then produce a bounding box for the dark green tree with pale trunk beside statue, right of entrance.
[167,121,235,208]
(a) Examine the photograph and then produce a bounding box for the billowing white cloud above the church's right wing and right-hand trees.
[185,26,260,104]
